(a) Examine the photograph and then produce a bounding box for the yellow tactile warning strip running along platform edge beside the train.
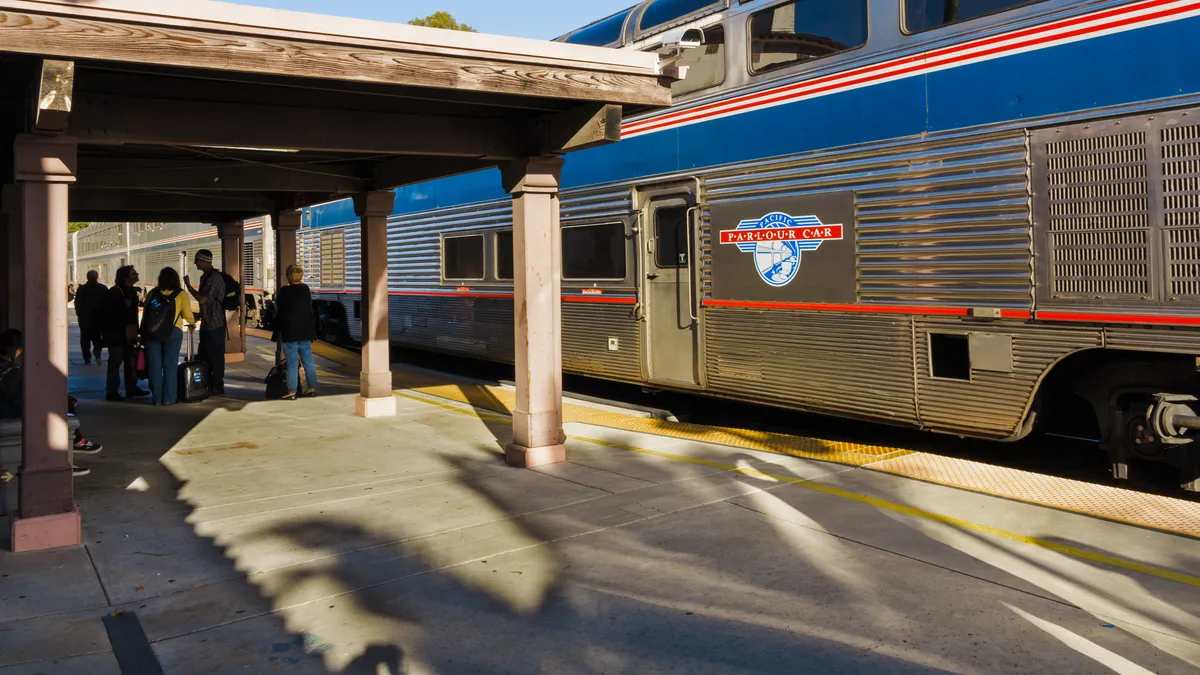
[283,344,1200,538]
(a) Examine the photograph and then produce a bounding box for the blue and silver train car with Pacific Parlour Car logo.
[301,0,1200,489]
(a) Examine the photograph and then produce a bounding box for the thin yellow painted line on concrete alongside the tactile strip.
[396,392,1200,587]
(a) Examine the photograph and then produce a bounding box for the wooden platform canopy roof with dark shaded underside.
[0,0,670,222]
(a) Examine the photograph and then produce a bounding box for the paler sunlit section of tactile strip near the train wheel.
[868,453,1200,538]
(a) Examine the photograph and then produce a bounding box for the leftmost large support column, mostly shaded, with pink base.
[12,135,80,551]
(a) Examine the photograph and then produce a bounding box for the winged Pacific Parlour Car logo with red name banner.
[721,213,842,283]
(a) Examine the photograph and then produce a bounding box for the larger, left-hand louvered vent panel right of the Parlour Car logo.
[1046,131,1152,299]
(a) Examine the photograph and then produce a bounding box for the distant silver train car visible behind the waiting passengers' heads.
[68,220,275,325]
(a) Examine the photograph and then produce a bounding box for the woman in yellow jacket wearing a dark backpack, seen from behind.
[142,267,196,406]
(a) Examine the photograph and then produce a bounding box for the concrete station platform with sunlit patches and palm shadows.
[0,329,1200,675]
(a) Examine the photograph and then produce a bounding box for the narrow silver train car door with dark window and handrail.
[642,193,700,387]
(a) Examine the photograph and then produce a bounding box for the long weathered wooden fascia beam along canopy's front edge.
[0,0,671,106]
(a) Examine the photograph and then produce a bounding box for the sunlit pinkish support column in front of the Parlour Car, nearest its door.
[503,157,566,467]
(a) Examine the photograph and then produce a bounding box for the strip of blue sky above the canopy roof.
[238,0,637,40]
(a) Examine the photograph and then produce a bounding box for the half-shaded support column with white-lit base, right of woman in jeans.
[354,190,396,417]
